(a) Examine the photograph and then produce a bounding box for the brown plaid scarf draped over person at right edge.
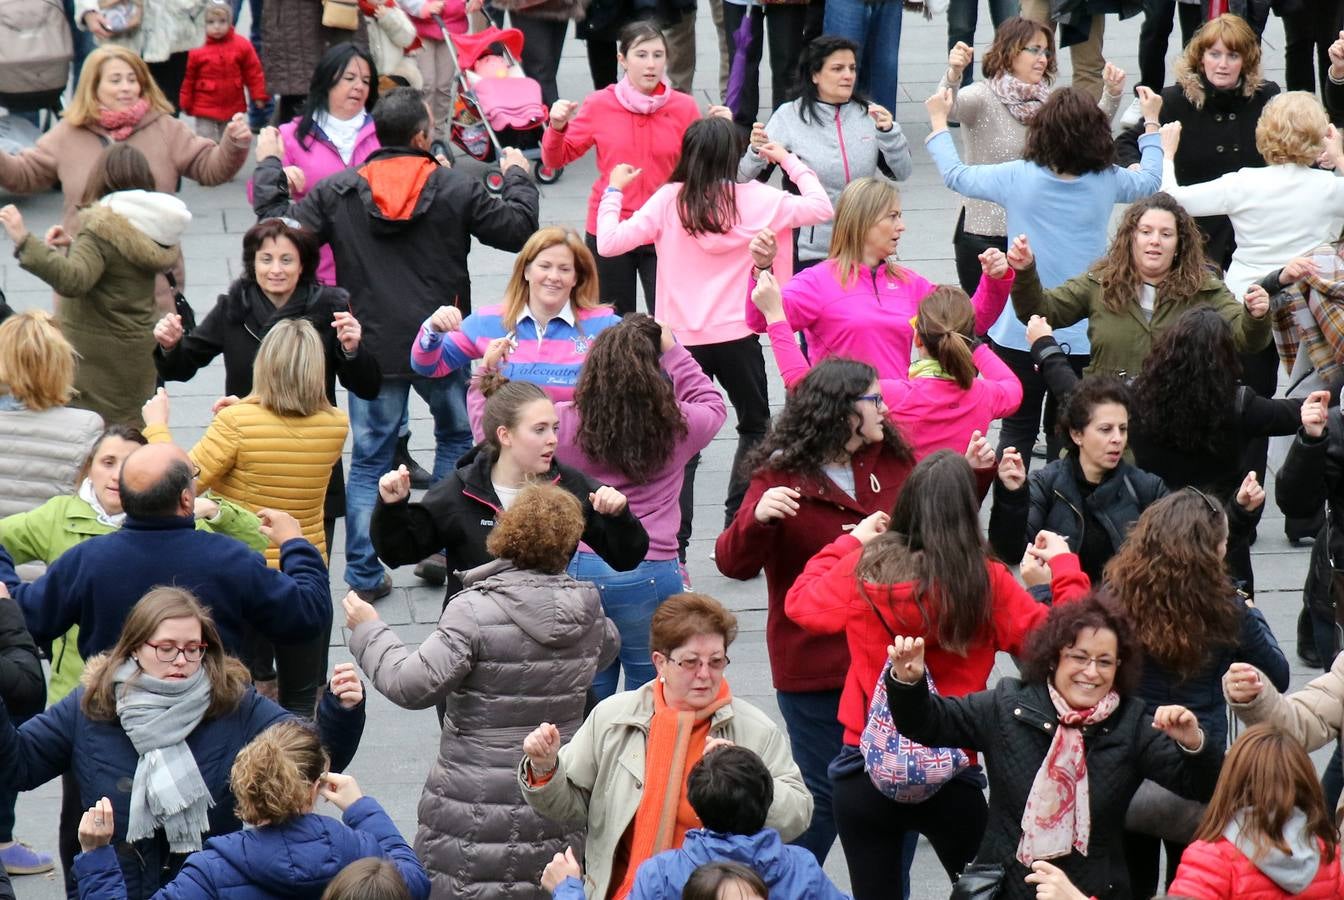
[1270,244,1344,384]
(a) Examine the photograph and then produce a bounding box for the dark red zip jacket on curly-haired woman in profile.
[714,445,911,690]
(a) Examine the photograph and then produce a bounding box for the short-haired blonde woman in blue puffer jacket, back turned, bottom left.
[75,720,429,900]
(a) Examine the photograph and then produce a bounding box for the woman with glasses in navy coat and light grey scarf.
[0,587,364,900]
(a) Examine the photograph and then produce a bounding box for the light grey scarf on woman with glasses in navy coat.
[113,660,214,853]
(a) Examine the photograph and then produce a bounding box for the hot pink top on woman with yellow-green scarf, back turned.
[766,322,1021,462]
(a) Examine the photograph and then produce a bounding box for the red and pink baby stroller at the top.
[438,20,563,193]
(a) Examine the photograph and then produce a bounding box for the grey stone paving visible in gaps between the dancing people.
[0,4,1324,900]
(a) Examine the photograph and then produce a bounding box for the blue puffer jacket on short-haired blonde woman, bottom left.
[74,797,429,900]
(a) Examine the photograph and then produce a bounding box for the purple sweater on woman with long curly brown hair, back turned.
[555,344,728,560]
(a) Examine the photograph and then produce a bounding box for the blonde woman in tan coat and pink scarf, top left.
[0,44,251,310]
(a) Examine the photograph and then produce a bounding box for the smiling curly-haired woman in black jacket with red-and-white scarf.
[883,596,1223,900]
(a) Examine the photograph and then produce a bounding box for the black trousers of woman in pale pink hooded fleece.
[676,333,770,561]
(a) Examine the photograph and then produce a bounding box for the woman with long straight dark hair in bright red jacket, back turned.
[785,450,1090,900]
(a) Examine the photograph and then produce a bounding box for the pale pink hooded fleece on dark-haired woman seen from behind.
[597,153,827,347]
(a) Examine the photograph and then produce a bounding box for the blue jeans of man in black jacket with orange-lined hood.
[345,368,472,591]
